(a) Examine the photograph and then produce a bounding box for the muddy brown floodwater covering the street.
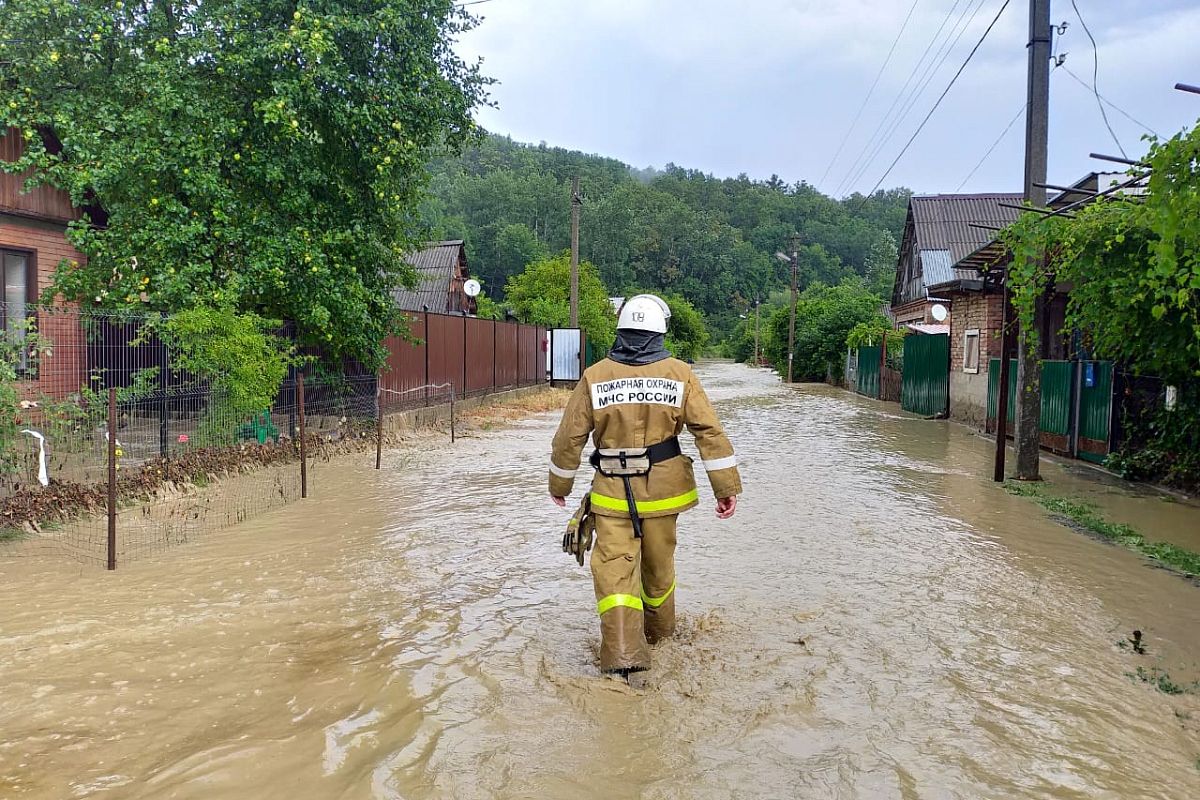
[0,365,1200,800]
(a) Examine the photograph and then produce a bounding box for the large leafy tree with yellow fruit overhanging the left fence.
[0,0,486,362]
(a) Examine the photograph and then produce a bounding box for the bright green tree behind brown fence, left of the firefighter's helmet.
[504,252,617,349]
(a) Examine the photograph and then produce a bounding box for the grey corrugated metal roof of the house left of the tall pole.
[910,192,1021,280]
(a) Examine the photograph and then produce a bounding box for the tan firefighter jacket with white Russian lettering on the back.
[550,359,742,518]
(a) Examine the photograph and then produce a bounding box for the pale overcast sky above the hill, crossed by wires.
[458,0,1200,196]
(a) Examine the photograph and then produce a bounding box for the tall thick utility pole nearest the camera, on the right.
[1006,0,1051,481]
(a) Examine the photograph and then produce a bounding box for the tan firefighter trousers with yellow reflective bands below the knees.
[592,515,679,672]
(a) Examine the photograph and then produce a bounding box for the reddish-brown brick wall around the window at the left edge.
[0,213,86,399]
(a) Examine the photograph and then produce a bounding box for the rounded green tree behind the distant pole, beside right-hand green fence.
[766,278,880,380]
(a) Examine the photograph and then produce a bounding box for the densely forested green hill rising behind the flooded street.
[424,136,910,335]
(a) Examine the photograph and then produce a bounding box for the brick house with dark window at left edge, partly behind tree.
[0,128,85,397]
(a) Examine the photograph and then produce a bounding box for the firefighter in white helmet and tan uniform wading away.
[550,295,742,678]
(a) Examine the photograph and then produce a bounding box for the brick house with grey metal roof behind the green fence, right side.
[892,193,1021,427]
